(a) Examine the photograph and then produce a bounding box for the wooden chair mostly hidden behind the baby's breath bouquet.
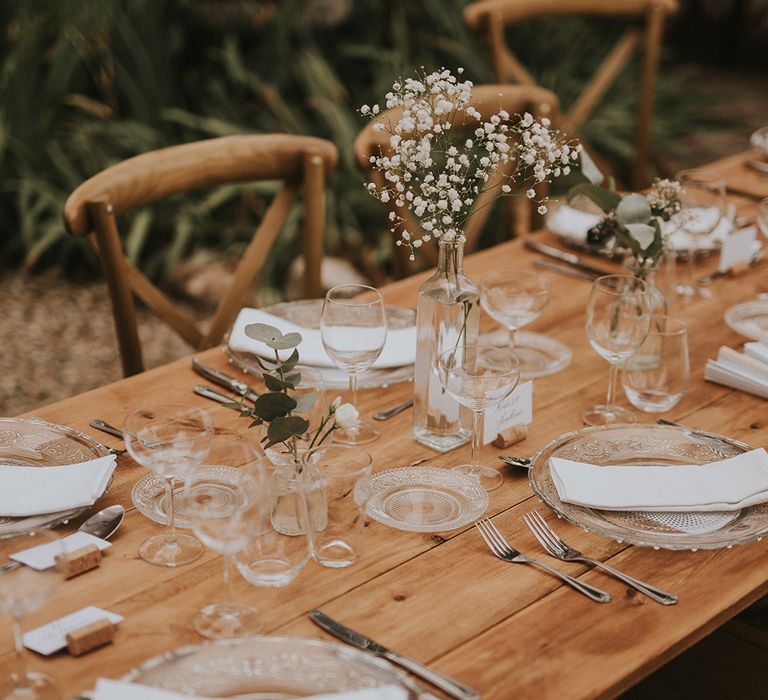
[354,85,559,278]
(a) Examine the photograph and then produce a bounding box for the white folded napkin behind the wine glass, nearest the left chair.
[229,308,416,368]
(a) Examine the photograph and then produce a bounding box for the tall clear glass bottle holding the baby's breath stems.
[413,241,480,452]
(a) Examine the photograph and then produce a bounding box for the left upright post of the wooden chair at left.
[88,201,144,377]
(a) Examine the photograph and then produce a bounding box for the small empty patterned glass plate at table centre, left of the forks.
[367,467,488,532]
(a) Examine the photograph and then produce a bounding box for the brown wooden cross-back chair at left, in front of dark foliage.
[64,134,338,376]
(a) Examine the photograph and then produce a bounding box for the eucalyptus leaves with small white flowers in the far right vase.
[568,179,681,268]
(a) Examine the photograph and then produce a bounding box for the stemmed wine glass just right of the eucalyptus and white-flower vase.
[672,170,725,301]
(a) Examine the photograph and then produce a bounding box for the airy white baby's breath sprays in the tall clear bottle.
[360,68,581,260]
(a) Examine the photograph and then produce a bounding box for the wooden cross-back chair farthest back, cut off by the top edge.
[464,0,678,188]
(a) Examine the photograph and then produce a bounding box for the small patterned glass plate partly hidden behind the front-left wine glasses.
[131,466,240,529]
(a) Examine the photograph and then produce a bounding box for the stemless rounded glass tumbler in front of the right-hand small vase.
[621,316,691,413]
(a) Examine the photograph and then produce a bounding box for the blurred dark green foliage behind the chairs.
[0,0,752,293]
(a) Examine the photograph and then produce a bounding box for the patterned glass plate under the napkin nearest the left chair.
[224,299,416,389]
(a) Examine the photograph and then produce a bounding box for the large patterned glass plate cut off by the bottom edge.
[123,637,417,700]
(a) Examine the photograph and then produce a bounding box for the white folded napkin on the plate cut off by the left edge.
[0,455,115,517]
